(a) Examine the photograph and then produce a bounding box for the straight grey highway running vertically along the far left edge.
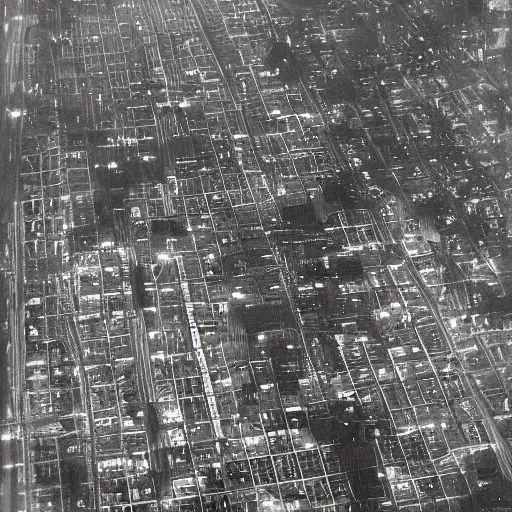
[0,0,28,511]
